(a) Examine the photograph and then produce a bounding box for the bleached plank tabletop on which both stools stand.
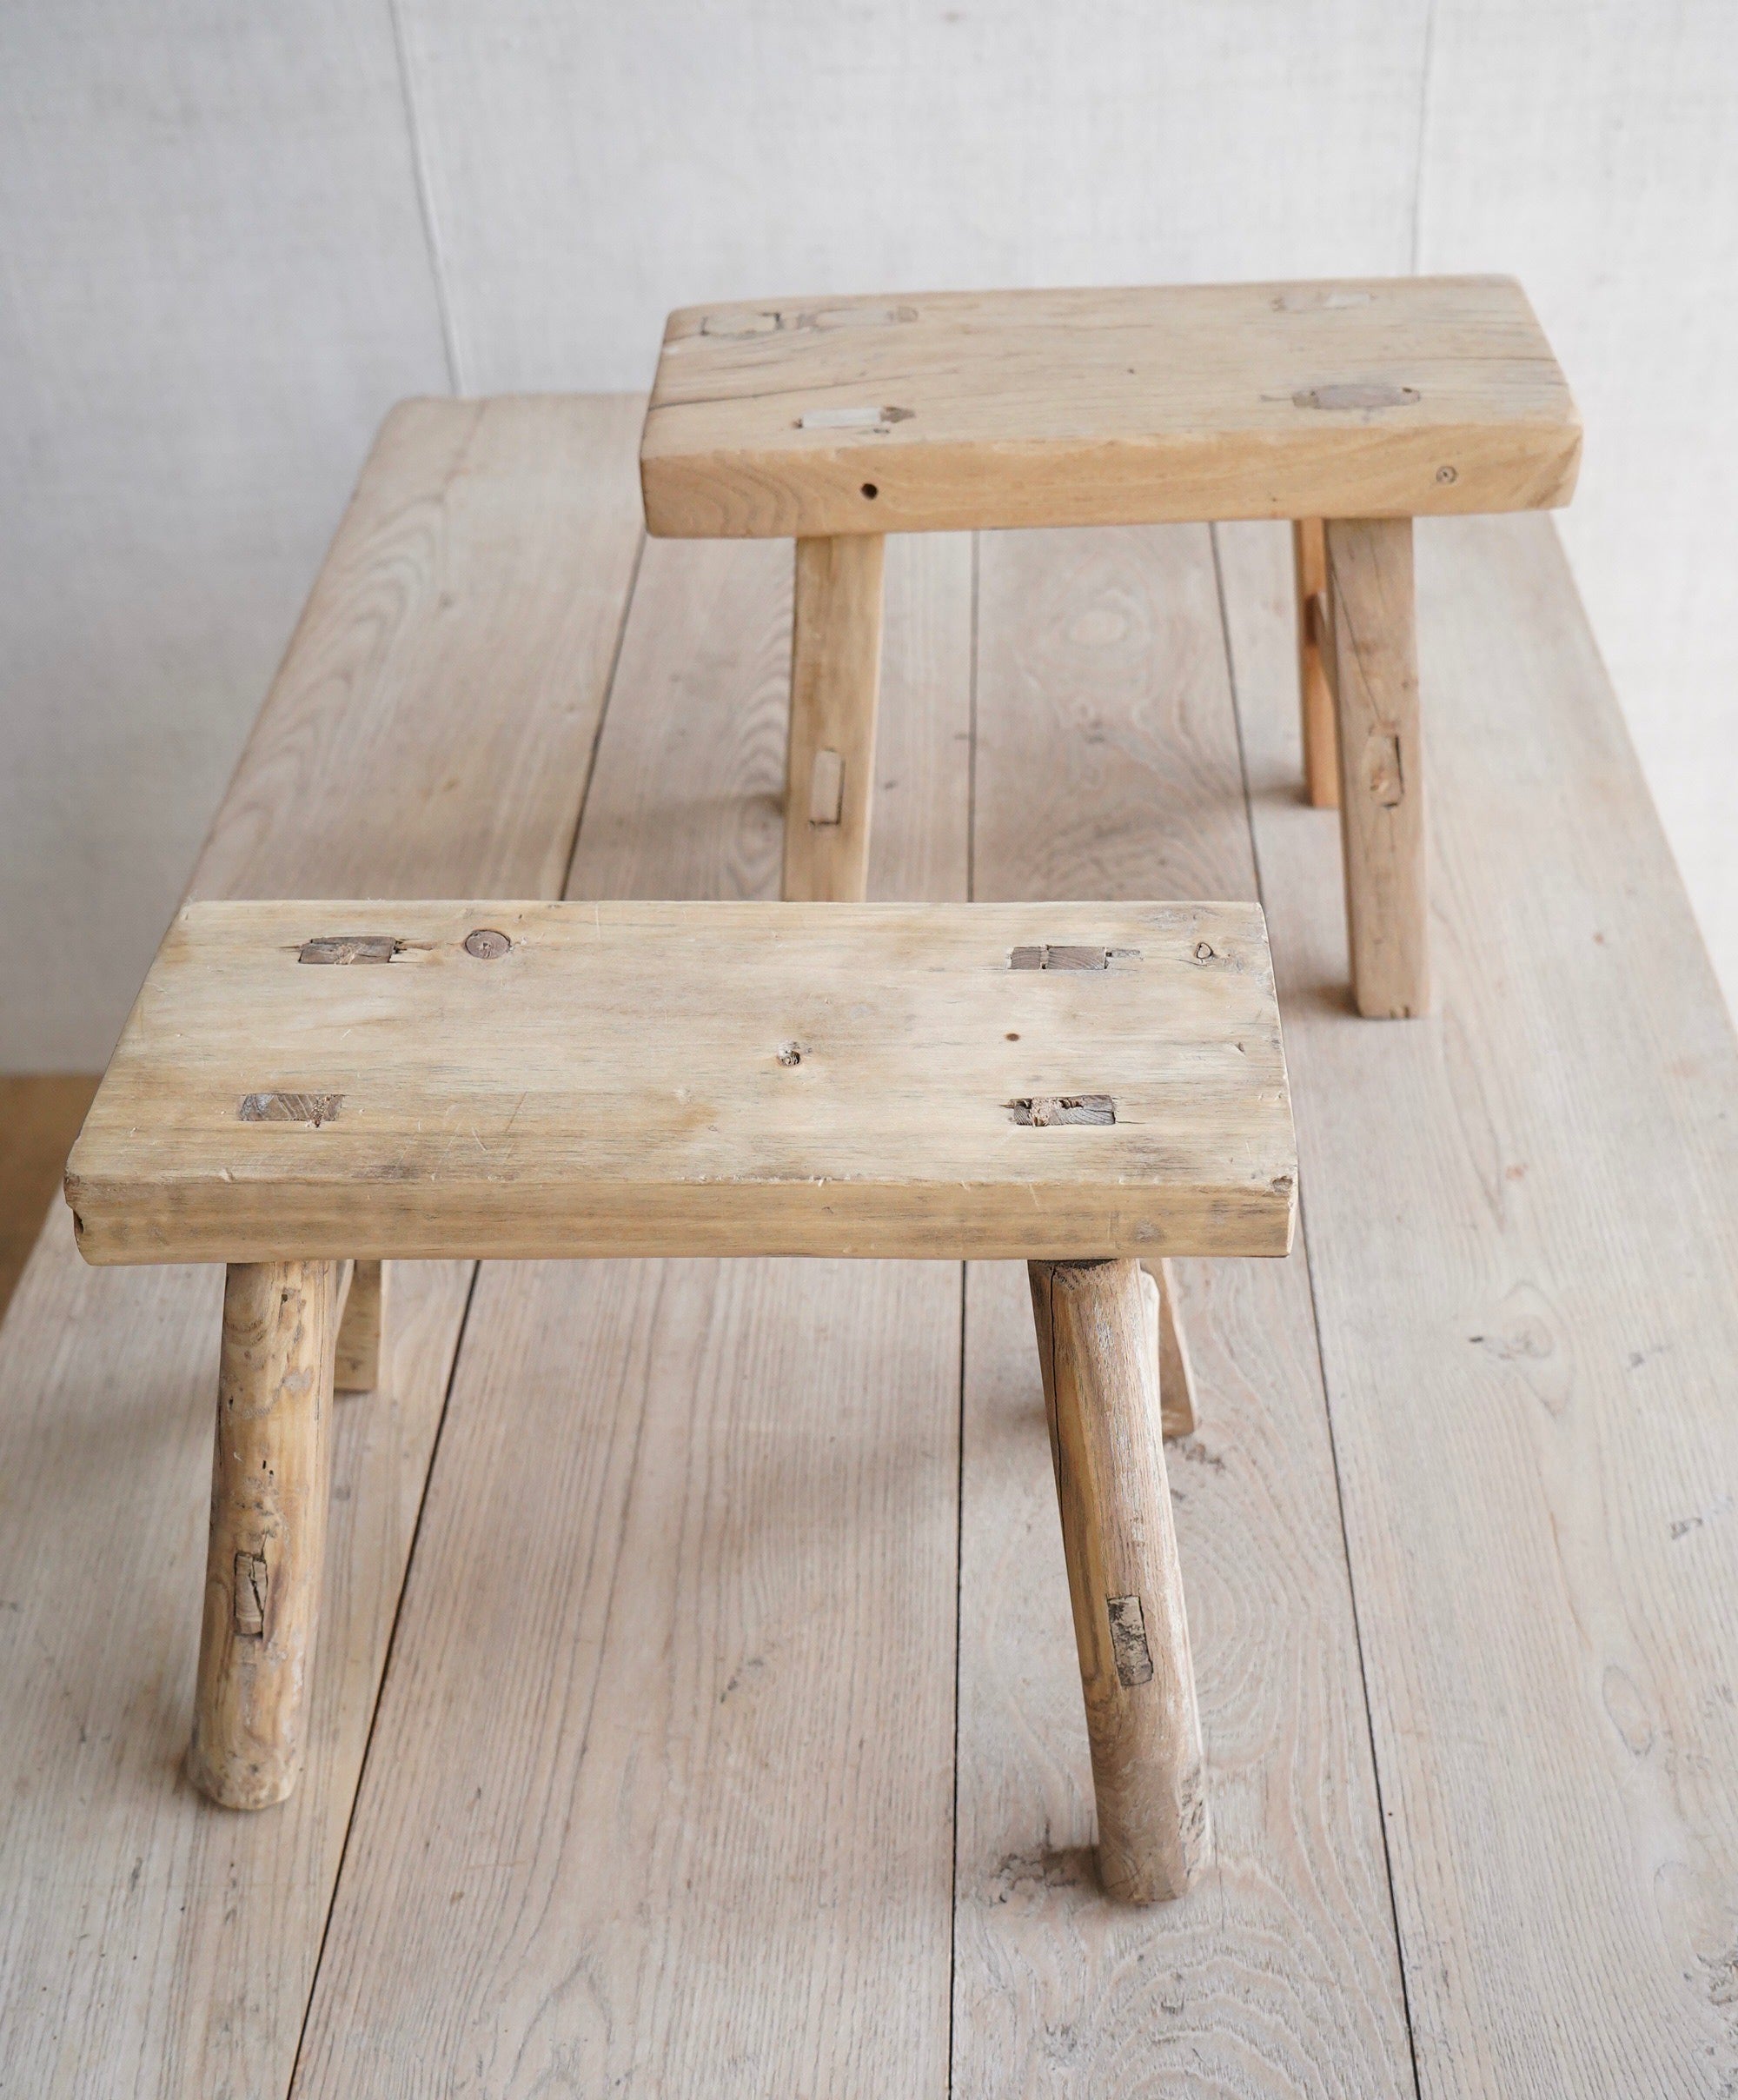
[0,403,1738,2100]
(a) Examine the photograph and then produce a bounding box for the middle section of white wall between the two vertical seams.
[403,0,1425,390]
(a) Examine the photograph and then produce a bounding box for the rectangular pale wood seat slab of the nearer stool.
[67,903,1297,1262]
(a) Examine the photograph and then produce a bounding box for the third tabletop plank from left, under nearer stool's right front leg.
[953,529,1410,2100]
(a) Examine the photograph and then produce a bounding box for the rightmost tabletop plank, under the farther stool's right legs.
[1197,521,1738,2100]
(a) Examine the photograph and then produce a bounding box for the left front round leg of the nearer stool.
[189,1262,338,1808]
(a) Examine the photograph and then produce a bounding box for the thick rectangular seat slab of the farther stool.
[640,277,1581,537]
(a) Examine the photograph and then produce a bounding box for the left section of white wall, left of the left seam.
[0,0,447,1071]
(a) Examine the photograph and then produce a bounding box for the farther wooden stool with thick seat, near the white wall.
[640,277,1581,1014]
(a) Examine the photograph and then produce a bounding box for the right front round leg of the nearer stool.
[1029,1262,1207,1903]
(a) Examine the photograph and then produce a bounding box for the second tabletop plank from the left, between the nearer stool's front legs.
[296,516,969,2100]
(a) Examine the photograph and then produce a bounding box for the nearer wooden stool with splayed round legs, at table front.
[67,903,1297,1903]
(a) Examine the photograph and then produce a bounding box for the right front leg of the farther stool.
[1327,519,1430,1016]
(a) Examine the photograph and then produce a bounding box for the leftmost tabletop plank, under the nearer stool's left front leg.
[0,403,638,2100]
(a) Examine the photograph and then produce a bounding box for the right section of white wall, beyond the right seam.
[1419,0,1738,1006]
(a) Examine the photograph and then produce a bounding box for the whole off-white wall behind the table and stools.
[0,0,1738,1050]
